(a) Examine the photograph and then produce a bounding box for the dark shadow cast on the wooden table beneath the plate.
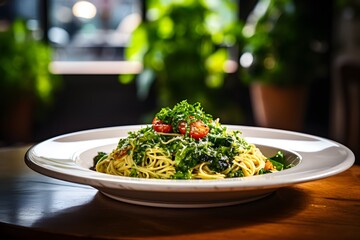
[22,187,308,239]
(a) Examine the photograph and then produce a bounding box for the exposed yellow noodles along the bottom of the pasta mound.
[96,134,276,179]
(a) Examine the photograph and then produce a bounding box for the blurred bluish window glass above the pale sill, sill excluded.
[47,0,141,61]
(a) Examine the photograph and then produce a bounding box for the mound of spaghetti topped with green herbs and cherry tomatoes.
[94,101,286,179]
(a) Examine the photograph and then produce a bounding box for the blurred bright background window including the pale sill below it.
[4,0,144,74]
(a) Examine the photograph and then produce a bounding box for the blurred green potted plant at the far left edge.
[0,19,60,142]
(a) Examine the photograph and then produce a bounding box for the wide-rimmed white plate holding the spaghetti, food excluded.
[25,125,355,208]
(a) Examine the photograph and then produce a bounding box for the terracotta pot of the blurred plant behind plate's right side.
[250,83,307,131]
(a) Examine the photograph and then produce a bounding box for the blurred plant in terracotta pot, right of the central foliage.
[240,0,324,130]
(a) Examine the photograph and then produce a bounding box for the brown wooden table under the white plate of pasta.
[0,147,360,240]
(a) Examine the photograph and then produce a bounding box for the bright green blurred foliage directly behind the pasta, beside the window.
[120,0,242,123]
